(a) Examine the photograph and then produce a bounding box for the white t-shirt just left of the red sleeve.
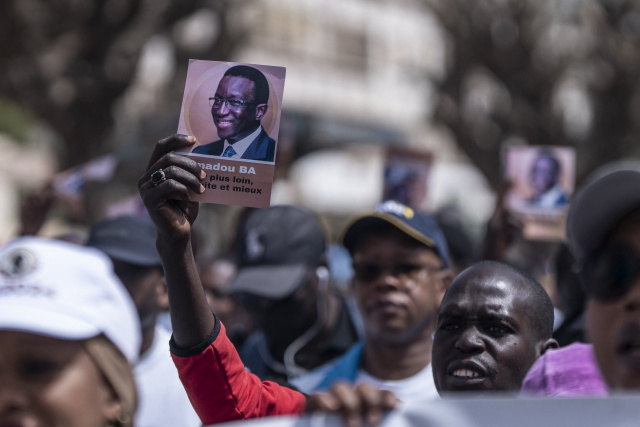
[133,325,202,427]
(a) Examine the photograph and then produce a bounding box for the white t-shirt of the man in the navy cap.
[355,363,440,403]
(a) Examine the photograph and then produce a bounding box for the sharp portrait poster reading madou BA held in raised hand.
[178,59,286,208]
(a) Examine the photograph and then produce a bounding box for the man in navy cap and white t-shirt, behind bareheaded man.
[293,201,453,402]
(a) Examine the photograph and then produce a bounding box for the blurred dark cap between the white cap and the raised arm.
[87,216,162,267]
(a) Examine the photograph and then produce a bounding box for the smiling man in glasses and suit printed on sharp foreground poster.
[193,65,276,162]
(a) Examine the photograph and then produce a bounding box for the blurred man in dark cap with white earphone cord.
[230,205,358,382]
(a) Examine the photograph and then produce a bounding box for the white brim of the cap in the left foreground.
[0,305,101,340]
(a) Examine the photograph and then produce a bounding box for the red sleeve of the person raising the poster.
[171,319,306,425]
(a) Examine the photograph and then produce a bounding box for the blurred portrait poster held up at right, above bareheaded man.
[505,146,575,241]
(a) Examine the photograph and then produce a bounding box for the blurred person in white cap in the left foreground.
[0,237,140,427]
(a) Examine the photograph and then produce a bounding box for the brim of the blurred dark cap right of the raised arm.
[230,264,309,299]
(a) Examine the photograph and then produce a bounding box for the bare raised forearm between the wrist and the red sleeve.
[156,234,215,348]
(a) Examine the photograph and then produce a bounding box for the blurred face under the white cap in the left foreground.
[0,330,122,427]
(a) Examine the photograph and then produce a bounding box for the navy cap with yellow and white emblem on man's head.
[342,200,449,267]
